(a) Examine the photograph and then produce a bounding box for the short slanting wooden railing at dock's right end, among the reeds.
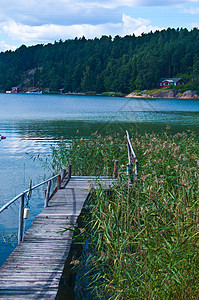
[126,130,138,181]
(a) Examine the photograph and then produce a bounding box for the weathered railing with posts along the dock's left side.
[0,165,71,244]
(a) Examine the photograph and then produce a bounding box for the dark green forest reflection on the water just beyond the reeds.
[13,117,199,139]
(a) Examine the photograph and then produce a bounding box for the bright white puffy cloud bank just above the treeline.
[2,14,160,44]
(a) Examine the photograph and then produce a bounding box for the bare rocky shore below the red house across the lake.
[126,90,199,99]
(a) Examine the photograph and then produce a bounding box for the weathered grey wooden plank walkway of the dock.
[0,176,113,300]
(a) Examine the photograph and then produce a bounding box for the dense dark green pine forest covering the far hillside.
[0,28,199,93]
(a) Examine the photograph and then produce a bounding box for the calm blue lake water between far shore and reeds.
[0,94,199,265]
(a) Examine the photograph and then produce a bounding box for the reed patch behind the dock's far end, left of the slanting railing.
[52,132,127,176]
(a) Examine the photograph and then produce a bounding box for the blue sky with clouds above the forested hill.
[0,0,199,51]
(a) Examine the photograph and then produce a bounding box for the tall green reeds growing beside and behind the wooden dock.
[53,132,199,300]
